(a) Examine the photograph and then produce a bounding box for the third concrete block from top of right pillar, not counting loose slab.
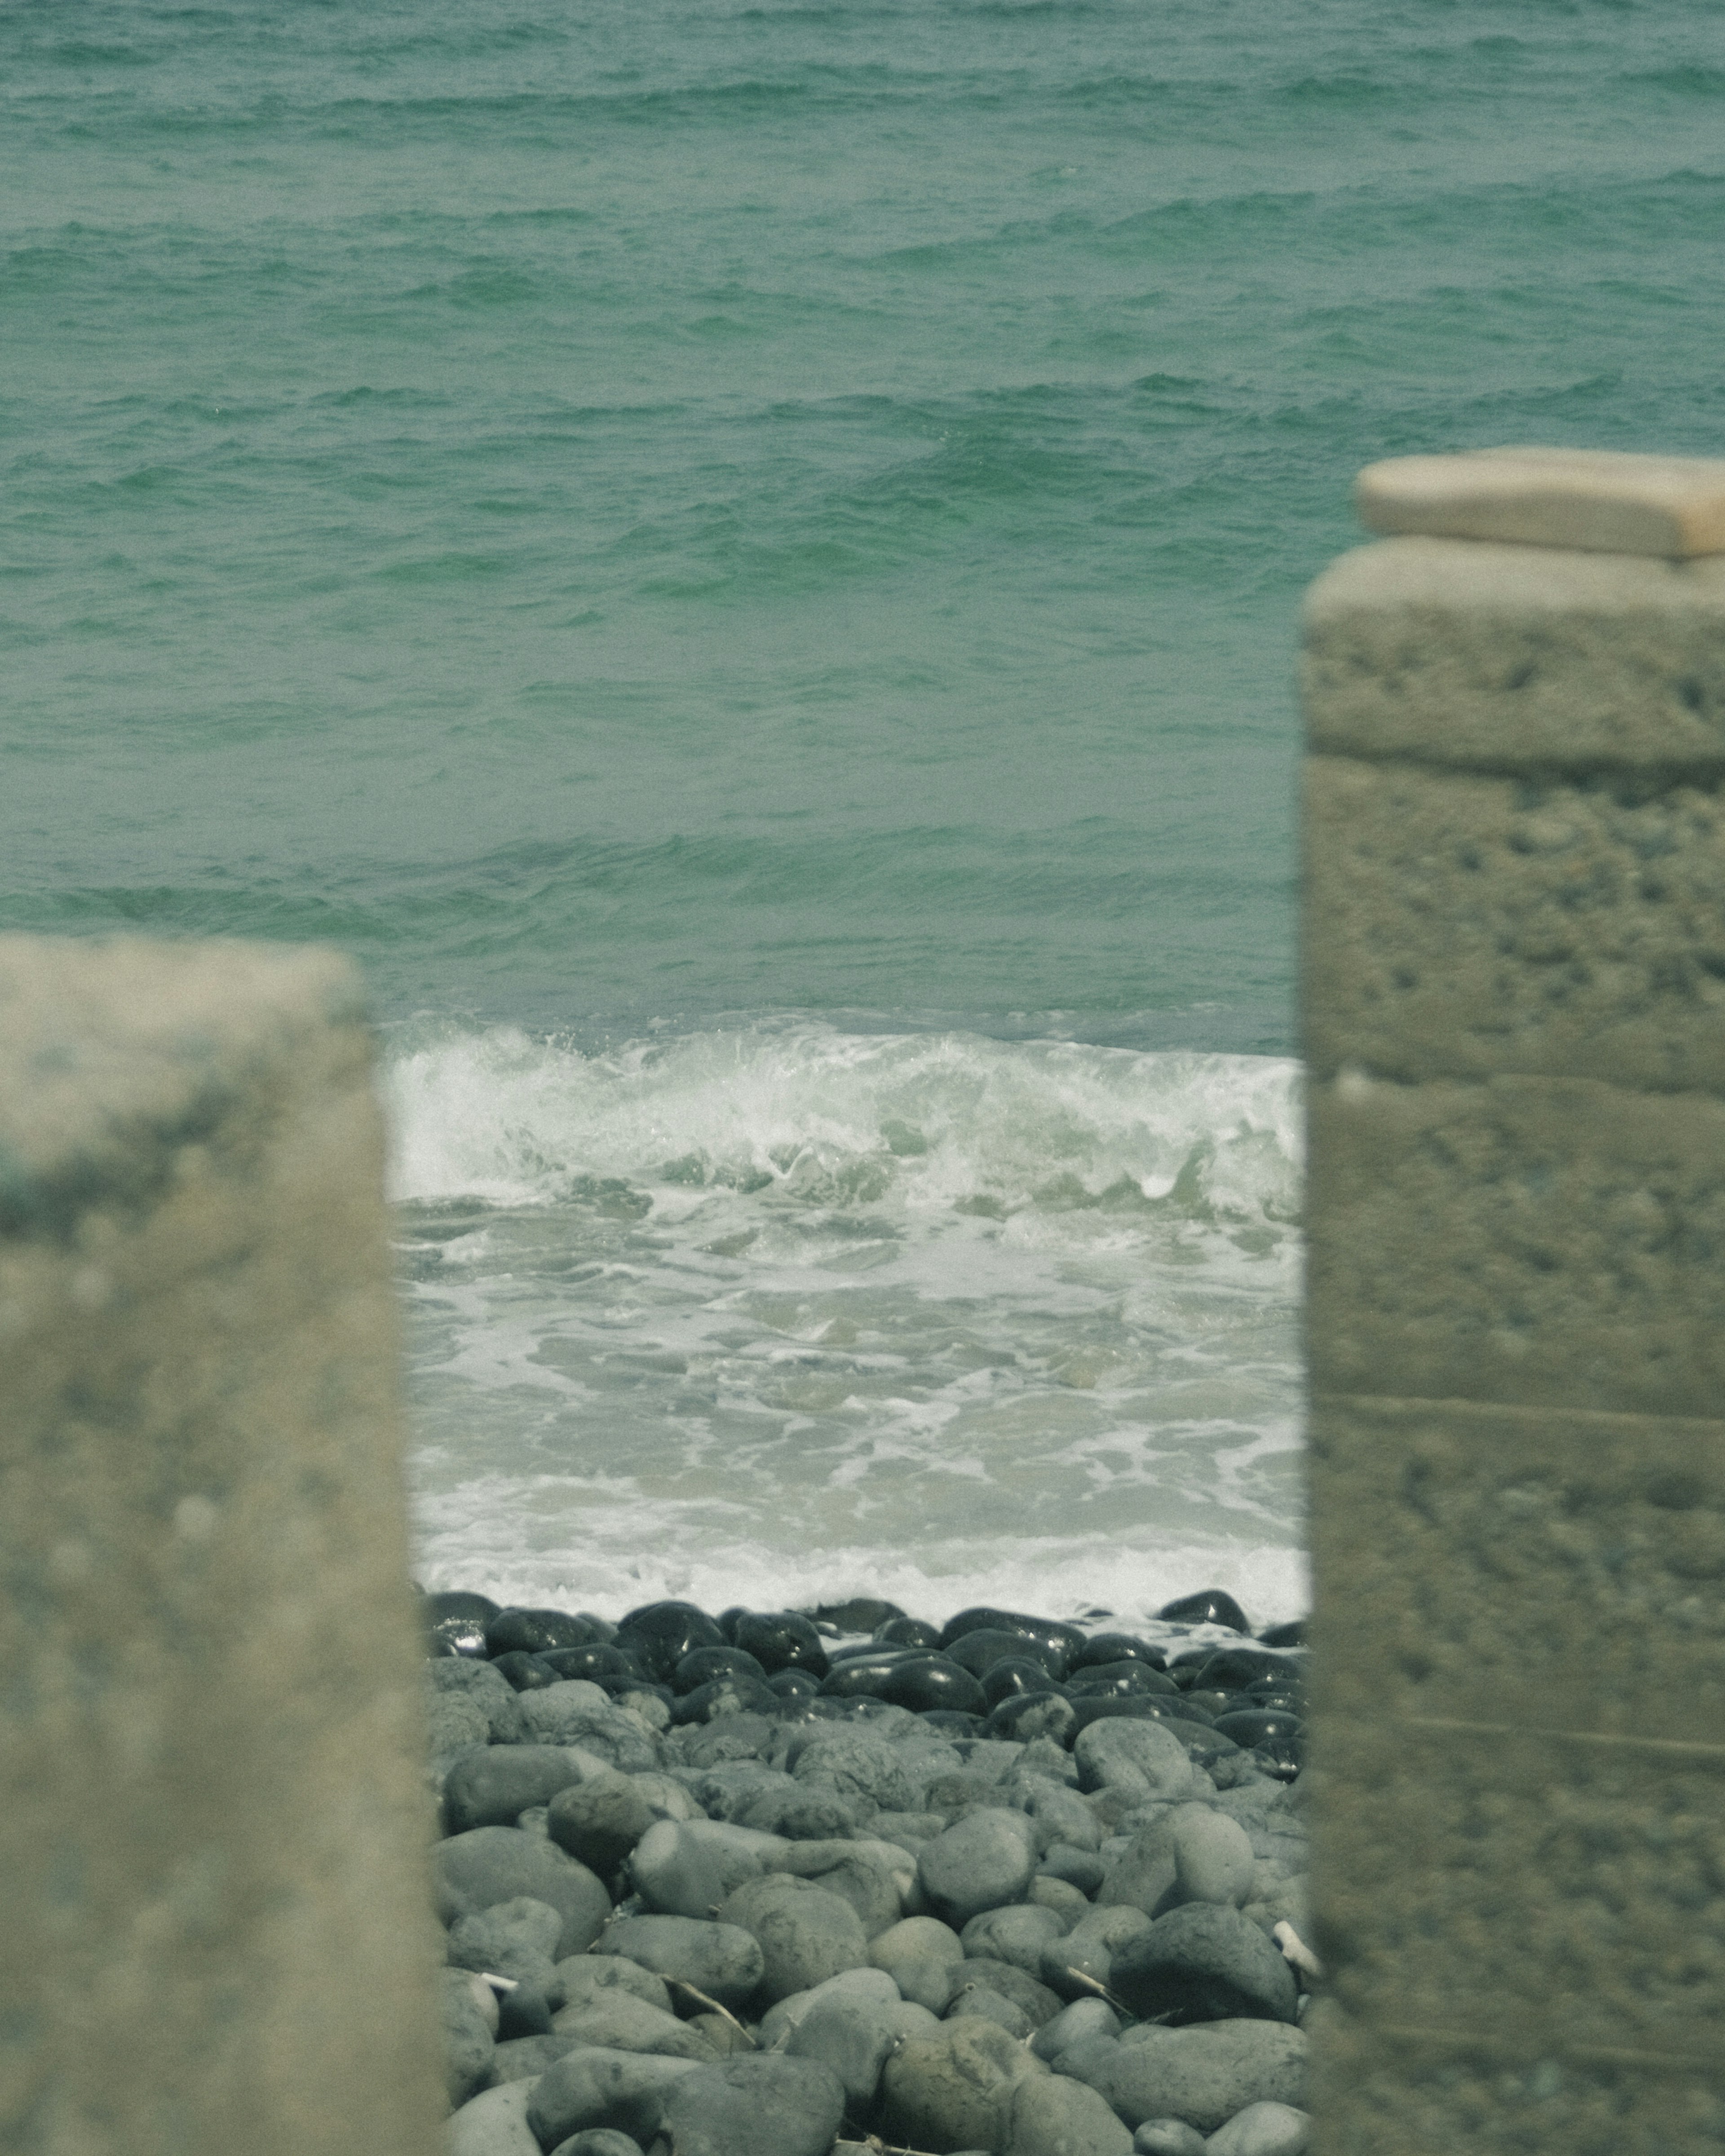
[1307,1072,1725,1418]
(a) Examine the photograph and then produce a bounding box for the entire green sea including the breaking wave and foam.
[0,0,1725,1617]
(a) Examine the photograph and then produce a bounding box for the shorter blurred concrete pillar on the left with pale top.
[0,938,442,2156]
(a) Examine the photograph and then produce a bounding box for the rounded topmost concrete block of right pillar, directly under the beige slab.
[1302,539,1725,778]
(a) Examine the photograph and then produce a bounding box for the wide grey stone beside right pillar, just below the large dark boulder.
[1061,2020,1307,2134]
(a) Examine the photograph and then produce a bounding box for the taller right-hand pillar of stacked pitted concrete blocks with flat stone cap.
[1302,451,1725,2156]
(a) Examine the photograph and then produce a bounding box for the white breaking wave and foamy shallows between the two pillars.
[388,1020,1305,1619]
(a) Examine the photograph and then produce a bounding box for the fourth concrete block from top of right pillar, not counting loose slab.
[1309,1395,1725,1750]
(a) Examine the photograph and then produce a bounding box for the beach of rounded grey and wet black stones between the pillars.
[423,1591,1320,2156]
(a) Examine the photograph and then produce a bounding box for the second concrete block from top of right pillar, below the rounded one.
[1302,757,1725,1093]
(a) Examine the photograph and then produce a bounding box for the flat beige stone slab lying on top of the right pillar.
[1354,448,1725,561]
